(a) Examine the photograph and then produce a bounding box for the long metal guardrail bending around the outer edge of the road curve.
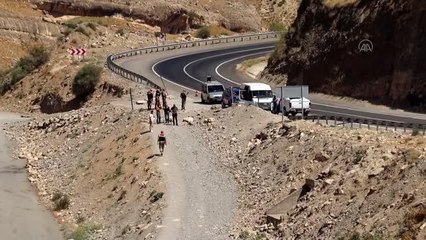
[106,32,281,88]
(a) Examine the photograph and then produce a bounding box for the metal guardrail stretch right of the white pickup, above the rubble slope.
[288,115,426,135]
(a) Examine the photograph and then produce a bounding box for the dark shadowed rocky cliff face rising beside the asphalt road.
[264,0,426,110]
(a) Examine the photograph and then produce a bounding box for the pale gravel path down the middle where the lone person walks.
[153,124,237,240]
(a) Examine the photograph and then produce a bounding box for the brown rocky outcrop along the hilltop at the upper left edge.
[37,0,204,33]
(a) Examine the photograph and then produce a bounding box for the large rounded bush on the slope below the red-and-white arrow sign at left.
[72,64,102,100]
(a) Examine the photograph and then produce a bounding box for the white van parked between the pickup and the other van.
[241,82,273,110]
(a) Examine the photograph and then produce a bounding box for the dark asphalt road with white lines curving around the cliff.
[152,43,426,125]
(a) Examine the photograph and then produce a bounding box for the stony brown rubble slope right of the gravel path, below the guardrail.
[191,106,426,239]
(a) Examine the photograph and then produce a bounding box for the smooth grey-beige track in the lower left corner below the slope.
[0,113,63,240]
